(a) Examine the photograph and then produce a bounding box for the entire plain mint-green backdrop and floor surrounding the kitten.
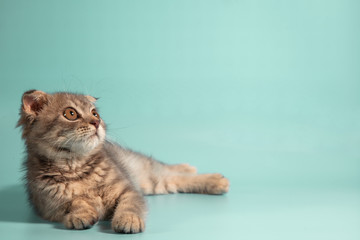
[0,0,360,240]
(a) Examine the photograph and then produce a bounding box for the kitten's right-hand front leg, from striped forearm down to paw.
[111,189,146,233]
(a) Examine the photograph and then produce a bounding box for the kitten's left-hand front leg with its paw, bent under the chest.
[63,198,103,230]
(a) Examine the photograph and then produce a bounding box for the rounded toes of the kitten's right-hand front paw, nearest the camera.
[111,212,145,233]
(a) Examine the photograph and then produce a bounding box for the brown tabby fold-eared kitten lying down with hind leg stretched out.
[18,90,229,233]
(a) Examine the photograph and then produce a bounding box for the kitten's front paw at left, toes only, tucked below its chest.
[64,212,99,230]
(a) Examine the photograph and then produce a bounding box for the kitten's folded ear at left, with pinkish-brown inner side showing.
[22,90,48,115]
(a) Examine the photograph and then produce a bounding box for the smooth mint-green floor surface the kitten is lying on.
[0,185,360,240]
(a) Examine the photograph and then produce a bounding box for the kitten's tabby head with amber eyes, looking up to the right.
[18,90,105,157]
